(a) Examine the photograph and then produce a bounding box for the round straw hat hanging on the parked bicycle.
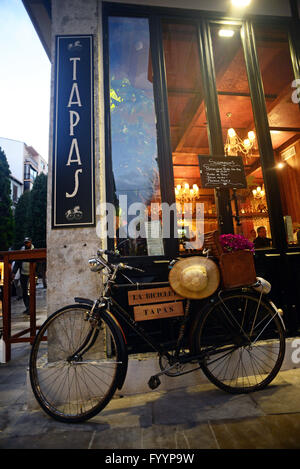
[169,256,220,299]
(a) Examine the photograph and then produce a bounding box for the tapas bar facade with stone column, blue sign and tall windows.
[23,0,300,344]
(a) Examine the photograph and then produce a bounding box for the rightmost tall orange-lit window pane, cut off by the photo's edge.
[254,25,300,245]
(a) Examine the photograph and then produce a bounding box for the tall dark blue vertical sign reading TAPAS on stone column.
[52,35,95,228]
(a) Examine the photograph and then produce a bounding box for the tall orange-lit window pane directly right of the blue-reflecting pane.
[163,22,217,252]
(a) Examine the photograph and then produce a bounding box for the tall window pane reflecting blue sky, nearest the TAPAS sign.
[109,17,164,256]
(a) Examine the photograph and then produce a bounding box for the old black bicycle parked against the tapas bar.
[29,250,285,423]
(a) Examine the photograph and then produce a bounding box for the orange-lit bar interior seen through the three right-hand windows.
[164,24,300,249]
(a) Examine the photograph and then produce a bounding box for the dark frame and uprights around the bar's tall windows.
[102,2,300,263]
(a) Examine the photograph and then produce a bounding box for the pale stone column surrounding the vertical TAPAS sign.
[47,0,106,315]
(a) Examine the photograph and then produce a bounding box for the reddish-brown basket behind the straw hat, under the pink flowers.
[203,231,256,288]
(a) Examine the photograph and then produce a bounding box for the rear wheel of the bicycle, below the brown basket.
[194,293,285,393]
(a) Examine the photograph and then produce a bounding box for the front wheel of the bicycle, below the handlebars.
[30,305,123,422]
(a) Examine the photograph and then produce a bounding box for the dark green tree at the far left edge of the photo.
[0,147,14,251]
